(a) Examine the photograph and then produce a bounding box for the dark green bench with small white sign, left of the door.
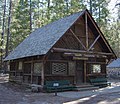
[44,80,75,92]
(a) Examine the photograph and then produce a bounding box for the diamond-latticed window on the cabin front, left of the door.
[52,63,67,75]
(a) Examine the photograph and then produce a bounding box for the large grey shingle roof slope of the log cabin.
[5,12,83,61]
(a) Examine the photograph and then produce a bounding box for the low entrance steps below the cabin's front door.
[76,84,99,91]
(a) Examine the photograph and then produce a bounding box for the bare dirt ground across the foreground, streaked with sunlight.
[0,74,120,104]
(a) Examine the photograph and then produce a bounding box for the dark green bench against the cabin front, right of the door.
[90,77,111,87]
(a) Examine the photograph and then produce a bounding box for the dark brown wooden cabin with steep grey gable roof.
[5,10,116,90]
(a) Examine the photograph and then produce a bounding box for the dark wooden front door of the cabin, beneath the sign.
[76,61,84,85]
